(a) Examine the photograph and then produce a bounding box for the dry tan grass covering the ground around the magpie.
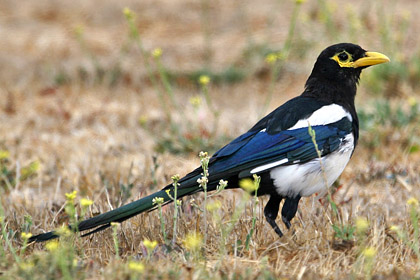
[0,0,420,279]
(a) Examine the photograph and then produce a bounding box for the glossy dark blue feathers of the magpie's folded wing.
[209,118,351,174]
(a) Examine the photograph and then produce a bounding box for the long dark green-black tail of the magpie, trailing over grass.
[29,184,201,242]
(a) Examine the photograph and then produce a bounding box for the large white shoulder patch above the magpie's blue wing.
[288,104,353,130]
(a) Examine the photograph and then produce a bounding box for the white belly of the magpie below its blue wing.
[270,133,354,197]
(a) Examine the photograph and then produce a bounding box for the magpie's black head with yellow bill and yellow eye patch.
[303,43,389,104]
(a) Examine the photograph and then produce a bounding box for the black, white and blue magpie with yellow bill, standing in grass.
[29,43,390,242]
